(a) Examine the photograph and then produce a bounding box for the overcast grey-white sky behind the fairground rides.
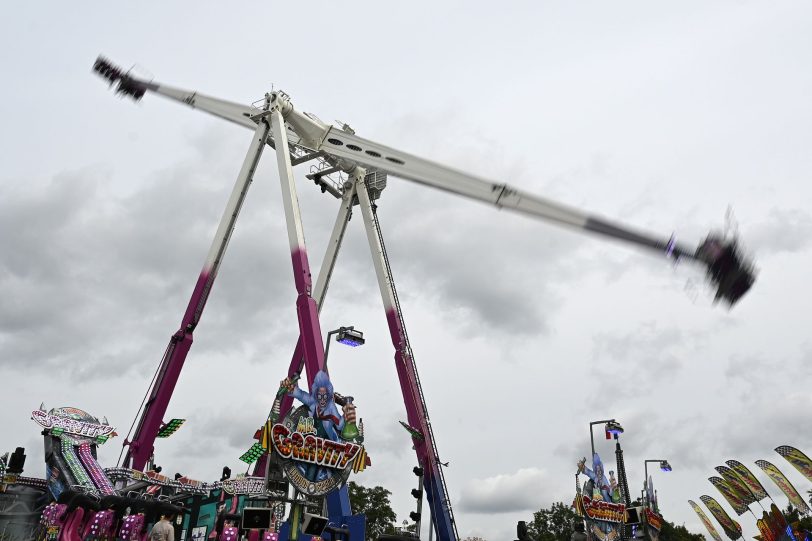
[0,0,812,541]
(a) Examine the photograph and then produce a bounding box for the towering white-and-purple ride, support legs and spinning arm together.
[89,57,754,541]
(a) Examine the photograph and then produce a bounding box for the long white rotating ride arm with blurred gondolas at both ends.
[94,57,755,305]
